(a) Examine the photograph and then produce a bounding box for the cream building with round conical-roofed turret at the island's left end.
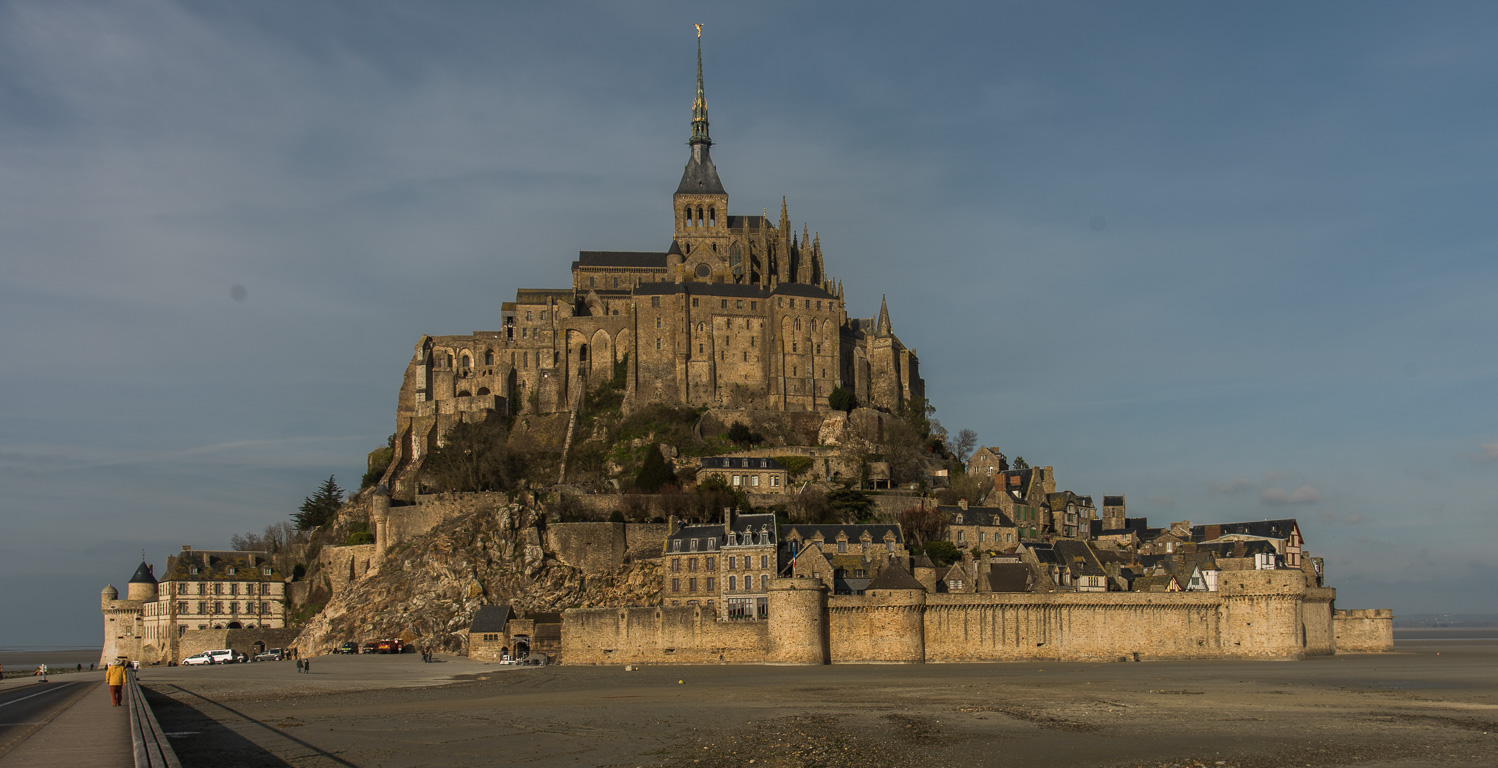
[100,545,286,663]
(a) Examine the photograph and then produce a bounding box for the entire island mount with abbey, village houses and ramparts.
[100,37,1393,665]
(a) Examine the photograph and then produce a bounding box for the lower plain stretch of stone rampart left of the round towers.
[562,605,768,665]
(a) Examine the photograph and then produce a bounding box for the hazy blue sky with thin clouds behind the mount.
[0,0,1498,645]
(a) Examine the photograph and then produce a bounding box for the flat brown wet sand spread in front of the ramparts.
[141,633,1498,768]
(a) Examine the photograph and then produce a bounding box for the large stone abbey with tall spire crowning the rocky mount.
[385,37,924,500]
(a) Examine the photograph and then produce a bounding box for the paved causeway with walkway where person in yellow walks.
[0,678,135,768]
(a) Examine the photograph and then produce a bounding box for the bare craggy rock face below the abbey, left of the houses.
[297,503,661,653]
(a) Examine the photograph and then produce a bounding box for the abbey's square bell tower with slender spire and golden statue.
[671,24,731,283]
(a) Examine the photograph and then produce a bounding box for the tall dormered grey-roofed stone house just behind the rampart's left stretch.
[661,509,777,620]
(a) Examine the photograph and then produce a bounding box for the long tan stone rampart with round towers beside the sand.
[562,570,1336,665]
